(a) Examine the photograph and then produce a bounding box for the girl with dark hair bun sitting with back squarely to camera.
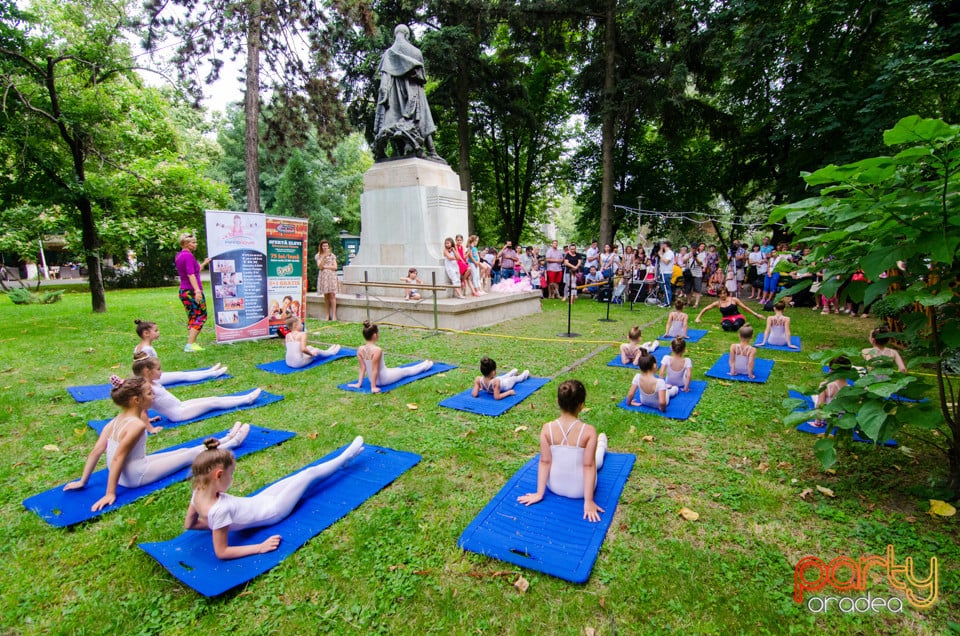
[517,380,607,521]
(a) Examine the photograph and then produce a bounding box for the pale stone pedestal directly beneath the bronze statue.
[343,157,467,297]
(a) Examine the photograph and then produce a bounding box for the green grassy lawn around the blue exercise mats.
[0,288,960,634]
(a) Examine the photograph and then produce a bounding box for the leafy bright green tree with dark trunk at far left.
[0,0,222,312]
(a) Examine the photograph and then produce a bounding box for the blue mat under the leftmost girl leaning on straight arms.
[23,426,296,528]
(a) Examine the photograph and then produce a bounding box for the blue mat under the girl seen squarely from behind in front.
[457,453,636,583]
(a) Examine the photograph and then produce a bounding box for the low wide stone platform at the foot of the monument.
[307,288,543,331]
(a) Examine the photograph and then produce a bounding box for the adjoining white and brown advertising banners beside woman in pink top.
[206,210,307,342]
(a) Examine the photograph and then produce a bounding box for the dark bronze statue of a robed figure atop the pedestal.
[373,24,440,161]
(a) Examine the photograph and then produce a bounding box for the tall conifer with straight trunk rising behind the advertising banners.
[144,0,372,212]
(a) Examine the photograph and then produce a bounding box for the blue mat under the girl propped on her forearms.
[139,445,420,596]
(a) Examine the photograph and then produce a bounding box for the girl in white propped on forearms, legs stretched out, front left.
[183,437,363,559]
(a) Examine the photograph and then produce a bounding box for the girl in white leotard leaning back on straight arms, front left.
[63,376,250,511]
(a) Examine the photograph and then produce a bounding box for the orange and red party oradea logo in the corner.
[793,545,940,614]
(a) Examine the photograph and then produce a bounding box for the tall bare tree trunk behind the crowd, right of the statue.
[600,0,617,245]
